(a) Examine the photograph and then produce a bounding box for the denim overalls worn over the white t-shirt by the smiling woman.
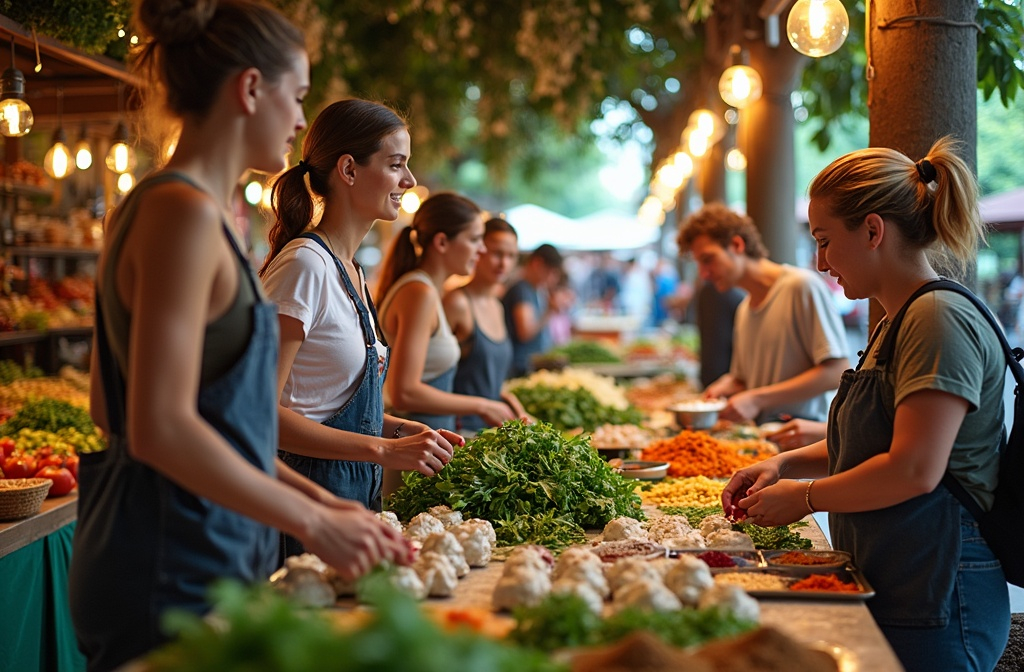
[278,233,389,557]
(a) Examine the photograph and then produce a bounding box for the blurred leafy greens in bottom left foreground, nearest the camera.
[146,583,562,672]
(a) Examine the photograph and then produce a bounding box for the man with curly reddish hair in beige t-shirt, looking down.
[678,203,849,423]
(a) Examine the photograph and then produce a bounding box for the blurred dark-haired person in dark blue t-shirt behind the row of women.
[502,243,562,378]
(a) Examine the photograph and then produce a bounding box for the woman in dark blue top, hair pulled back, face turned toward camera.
[443,217,526,431]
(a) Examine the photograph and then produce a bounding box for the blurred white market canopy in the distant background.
[505,203,660,252]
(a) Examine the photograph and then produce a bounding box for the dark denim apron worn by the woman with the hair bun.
[69,224,278,670]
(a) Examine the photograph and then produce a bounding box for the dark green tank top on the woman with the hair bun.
[99,172,256,385]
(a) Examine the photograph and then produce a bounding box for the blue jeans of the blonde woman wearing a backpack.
[882,508,1010,672]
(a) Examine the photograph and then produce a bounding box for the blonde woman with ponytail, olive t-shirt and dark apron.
[722,138,1010,672]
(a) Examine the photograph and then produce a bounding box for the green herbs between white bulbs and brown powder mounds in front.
[509,595,757,652]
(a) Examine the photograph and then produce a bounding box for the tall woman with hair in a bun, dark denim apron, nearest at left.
[69,6,411,671]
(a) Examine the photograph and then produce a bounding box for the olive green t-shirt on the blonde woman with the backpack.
[864,290,1007,510]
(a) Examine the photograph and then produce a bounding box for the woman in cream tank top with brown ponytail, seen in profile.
[377,193,515,429]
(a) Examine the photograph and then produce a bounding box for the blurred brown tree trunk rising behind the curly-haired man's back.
[739,40,806,263]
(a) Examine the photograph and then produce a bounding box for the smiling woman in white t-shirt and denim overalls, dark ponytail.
[260,99,462,555]
